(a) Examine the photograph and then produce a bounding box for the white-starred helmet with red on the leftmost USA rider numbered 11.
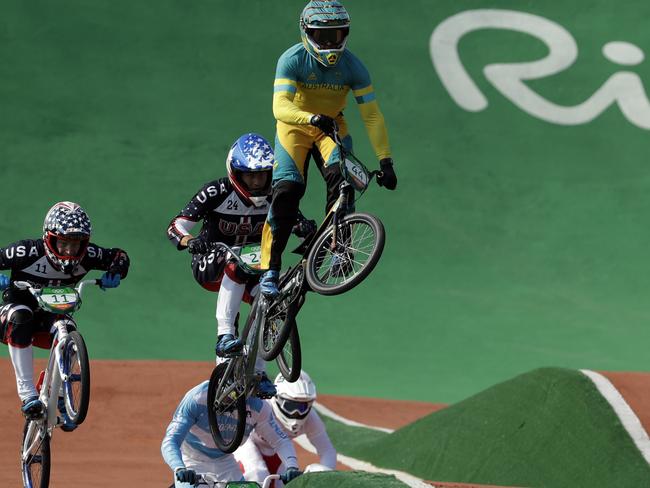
[43,202,92,274]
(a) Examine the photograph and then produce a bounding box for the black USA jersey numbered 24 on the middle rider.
[167,177,271,250]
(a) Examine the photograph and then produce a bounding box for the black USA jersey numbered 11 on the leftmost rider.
[0,239,129,286]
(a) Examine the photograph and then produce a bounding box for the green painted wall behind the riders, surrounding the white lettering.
[0,0,650,402]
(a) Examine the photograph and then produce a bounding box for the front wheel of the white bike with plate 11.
[63,331,90,425]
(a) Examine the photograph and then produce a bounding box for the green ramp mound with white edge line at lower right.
[325,368,650,488]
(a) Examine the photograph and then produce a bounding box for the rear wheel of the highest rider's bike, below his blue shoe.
[259,264,305,361]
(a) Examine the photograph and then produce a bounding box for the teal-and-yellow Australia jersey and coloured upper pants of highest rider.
[273,44,391,182]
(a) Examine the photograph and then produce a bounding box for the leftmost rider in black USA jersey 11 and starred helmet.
[0,202,129,424]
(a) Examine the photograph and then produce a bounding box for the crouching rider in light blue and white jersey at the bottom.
[161,381,301,488]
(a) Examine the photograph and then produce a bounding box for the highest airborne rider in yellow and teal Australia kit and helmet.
[260,0,397,296]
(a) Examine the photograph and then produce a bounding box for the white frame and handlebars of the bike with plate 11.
[14,280,97,462]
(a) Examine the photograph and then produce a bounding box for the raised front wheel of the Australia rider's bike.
[306,213,386,295]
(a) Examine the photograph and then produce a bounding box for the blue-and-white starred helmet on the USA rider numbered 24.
[226,133,274,207]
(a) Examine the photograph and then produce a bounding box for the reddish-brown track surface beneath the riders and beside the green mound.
[0,359,650,488]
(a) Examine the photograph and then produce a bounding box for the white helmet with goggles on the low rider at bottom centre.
[272,371,316,435]
